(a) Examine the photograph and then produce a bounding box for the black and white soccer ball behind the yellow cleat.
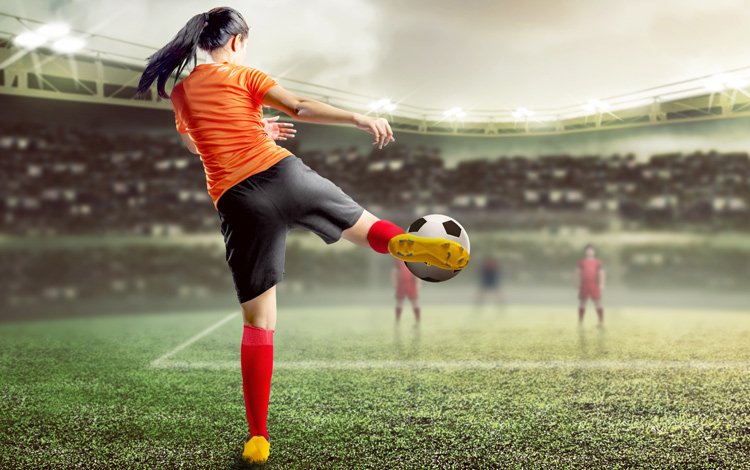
[404,214,470,282]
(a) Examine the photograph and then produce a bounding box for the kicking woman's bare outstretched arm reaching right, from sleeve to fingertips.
[263,85,395,149]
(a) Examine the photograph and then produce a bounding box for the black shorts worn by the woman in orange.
[217,155,364,303]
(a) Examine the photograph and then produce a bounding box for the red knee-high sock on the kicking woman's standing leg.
[240,325,273,439]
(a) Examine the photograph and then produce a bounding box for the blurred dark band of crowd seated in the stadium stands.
[0,124,750,235]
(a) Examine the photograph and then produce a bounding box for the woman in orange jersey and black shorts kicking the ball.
[138,8,469,463]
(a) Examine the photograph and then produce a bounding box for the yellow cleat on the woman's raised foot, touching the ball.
[388,233,469,271]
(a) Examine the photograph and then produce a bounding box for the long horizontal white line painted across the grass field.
[151,359,750,371]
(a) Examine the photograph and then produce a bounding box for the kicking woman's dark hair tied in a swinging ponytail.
[138,7,250,99]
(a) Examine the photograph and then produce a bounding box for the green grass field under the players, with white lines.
[0,306,750,469]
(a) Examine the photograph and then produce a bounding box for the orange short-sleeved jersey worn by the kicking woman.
[171,62,291,205]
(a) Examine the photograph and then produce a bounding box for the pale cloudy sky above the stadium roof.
[0,0,750,111]
